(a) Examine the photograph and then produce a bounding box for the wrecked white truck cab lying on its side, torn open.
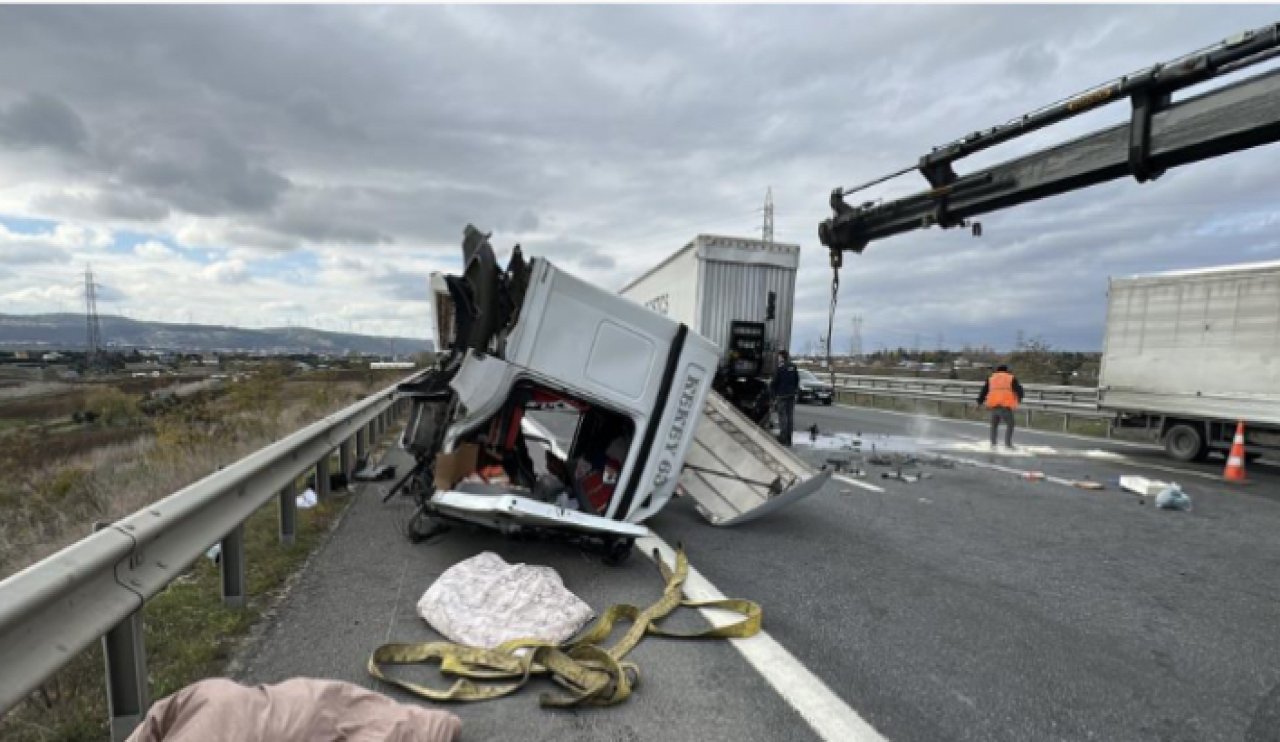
[401,229,718,547]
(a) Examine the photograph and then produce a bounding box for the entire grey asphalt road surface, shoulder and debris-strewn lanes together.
[239,407,1280,742]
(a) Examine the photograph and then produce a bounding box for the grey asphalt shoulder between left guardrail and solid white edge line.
[232,442,817,742]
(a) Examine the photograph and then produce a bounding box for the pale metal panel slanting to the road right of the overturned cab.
[680,391,831,526]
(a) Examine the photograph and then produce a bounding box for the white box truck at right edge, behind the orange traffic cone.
[1098,261,1280,461]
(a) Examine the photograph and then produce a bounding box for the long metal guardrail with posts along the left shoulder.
[0,373,417,739]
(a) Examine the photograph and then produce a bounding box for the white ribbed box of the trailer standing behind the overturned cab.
[620,234,800,352]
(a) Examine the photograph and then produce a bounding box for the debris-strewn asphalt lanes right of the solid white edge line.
[652,407,1280,741]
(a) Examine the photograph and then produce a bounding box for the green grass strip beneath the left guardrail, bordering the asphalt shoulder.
[0,488,349,742]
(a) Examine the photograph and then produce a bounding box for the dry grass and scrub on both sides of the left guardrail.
[0,366,398,741]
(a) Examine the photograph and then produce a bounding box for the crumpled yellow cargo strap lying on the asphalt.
[369,548,762,707]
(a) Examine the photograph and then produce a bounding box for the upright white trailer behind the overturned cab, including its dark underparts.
[620,234,800,423]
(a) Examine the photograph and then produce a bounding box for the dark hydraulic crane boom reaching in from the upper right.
[818,23,1280,260]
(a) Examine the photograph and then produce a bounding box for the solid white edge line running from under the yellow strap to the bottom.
[636,535,884,742]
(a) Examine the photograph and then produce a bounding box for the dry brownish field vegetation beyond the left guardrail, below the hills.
[0,366,390,578]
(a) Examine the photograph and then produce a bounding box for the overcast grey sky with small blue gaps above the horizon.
[0,5,1280,351]
